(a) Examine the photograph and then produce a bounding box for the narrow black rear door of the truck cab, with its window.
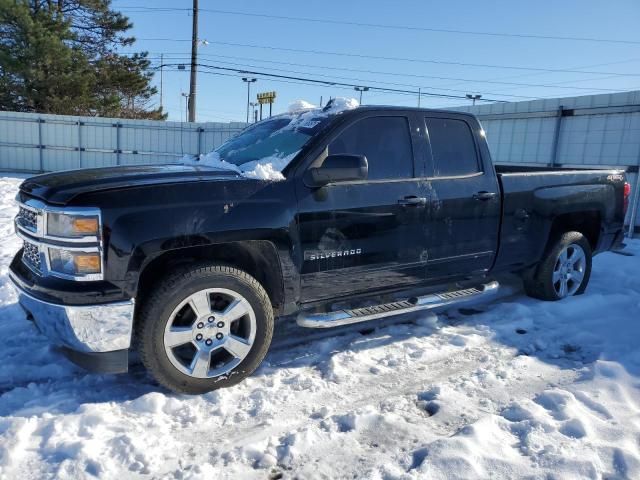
[424,114,501,279]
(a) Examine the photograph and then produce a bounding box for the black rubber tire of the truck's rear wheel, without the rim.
[524,232,593,301]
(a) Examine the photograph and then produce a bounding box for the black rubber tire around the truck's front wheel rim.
[136,263,274,394]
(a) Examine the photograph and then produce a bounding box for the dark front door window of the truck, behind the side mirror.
[329,117,413,180]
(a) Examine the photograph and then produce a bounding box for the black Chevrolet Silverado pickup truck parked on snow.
[10,105,629,393]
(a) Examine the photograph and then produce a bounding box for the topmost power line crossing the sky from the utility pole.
[115,6,640,45]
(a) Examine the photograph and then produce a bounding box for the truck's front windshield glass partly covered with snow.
[215,112,328,167]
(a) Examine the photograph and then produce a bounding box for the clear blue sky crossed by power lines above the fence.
[113,0,640,122]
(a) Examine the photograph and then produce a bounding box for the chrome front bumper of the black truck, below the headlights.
[9,270,135,373]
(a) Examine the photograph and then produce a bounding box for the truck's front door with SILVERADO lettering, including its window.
[296,112,428,302]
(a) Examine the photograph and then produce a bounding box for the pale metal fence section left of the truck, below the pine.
[0,112,245,172]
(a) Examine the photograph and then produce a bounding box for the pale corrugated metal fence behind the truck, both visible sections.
[0,91,640,233]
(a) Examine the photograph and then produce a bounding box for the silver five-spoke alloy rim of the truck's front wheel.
[164,288,256,378]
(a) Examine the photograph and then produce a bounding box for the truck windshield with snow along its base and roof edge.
[182,97,359,181]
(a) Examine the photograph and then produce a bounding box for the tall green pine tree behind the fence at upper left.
[0,0,166,119]
